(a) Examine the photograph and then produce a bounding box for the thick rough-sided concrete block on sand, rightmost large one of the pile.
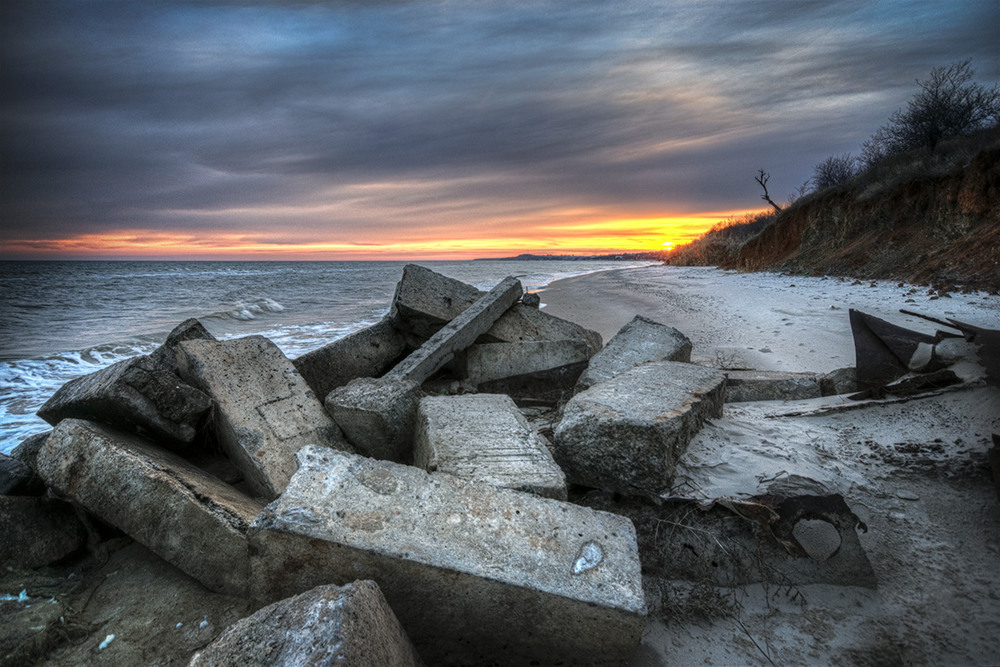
[555,361,726,495]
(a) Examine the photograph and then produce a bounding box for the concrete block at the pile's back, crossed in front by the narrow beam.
[389,264,602,354]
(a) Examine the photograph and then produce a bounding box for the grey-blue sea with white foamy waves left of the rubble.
[0,260,650,453]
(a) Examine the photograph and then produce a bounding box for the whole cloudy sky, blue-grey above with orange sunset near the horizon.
[0,0,1000,260]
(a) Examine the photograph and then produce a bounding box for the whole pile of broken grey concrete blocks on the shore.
[0,265,892,665]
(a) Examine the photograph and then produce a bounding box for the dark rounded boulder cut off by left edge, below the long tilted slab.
[0,496,87,568]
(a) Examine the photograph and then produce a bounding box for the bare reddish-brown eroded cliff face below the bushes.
[727,148,1000,291]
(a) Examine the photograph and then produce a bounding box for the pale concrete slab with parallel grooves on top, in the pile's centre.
[413,394,566,500]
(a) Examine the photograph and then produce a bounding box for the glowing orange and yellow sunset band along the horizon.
[3,210,747,260]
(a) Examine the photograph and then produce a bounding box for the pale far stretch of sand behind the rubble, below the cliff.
[539,265,1000,373]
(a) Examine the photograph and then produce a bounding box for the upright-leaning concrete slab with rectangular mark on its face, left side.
[177,336,353,498]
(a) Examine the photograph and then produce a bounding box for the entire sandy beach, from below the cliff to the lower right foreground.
[541,266,1000,665]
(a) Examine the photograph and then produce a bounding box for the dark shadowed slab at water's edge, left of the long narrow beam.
[292,318,407,399]
